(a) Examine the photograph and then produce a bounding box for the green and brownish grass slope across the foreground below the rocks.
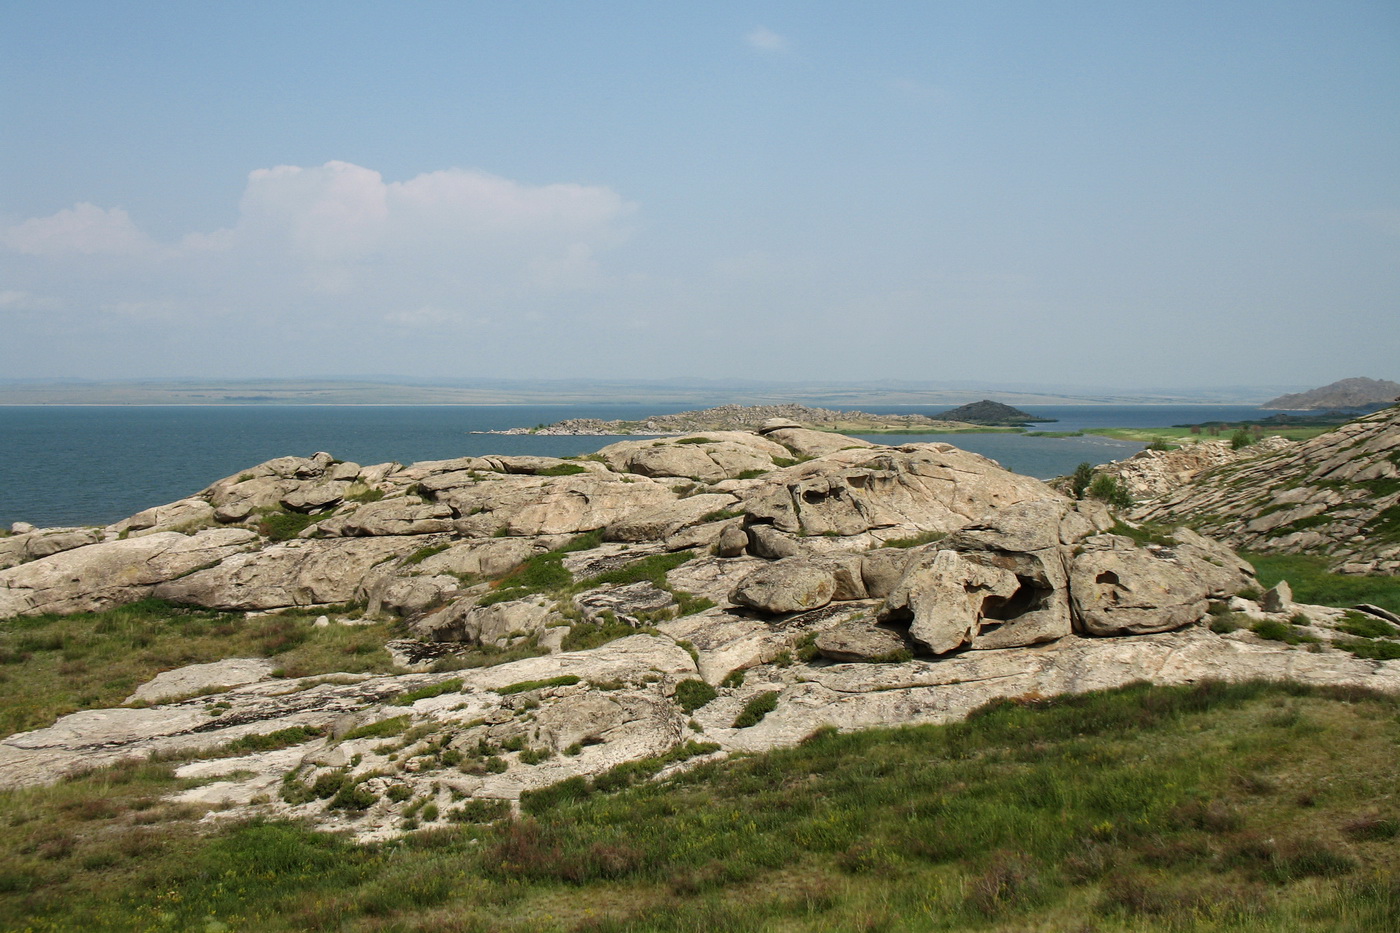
[0,684,1400,933]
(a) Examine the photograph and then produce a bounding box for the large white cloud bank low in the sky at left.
[0,161,634,322]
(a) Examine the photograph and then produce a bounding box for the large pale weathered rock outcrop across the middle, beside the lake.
[0,420,1400,839]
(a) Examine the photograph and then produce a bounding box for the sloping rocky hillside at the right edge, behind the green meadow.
[1113,406,1400,574]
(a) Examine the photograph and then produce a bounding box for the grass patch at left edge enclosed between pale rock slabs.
[0,600,395,735]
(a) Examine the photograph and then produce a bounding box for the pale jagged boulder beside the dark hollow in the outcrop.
[879,551,1019,654]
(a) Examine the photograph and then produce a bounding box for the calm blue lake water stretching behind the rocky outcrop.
[0,405,1282,527]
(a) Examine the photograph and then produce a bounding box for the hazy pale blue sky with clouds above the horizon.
[0,0,1400,387]
